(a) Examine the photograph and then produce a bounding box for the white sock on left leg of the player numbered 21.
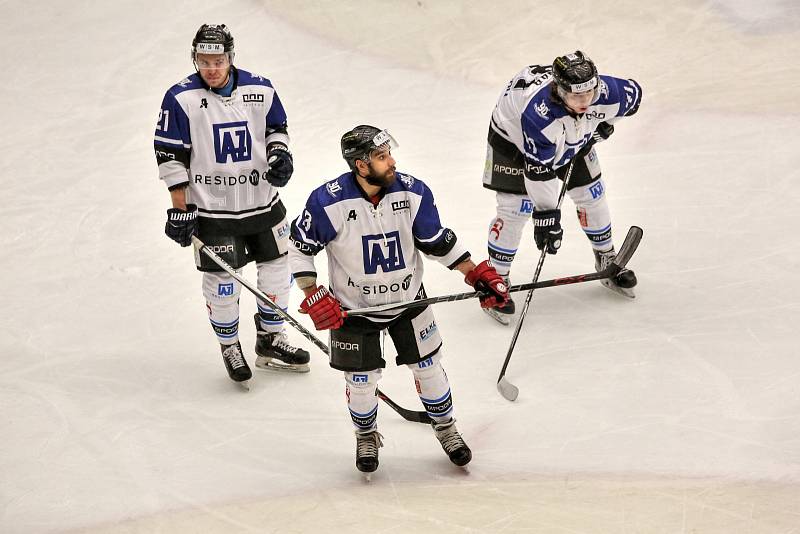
[203,272,242,345]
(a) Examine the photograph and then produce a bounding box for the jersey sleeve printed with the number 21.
[153,91,192,189]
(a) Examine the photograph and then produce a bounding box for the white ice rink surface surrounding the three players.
[0,0,800,534]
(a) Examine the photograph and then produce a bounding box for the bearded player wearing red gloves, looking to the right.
[289,125,508,473]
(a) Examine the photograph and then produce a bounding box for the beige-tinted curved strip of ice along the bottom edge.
[75,474,800,534]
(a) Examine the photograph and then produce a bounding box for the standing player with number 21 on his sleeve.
[155,24,309,385]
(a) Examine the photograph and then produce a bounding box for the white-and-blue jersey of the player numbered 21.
[155,68,289,235]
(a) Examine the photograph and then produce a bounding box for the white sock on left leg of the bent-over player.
[487,192,533,276]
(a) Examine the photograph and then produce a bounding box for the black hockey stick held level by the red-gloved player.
[344,226,642,317]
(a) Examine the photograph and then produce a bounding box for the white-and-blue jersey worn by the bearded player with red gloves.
[289,172,469,322]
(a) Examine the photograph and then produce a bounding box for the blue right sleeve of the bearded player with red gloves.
[411,181,470,269]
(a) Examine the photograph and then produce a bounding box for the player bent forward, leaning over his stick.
[483,51,642,324]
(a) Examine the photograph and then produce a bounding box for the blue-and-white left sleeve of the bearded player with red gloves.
[289,189,336,278]
